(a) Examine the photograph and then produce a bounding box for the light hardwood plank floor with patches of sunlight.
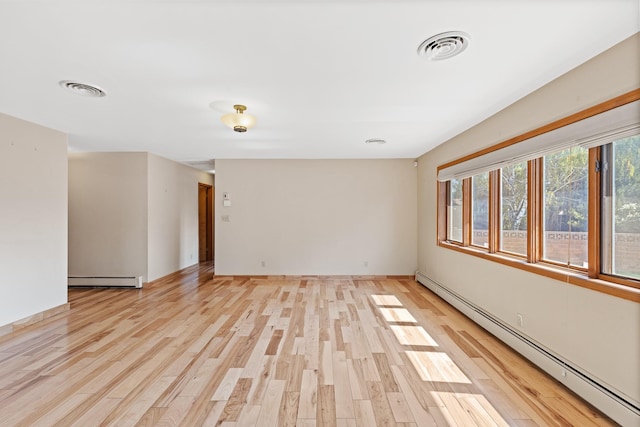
[0,263,613,427]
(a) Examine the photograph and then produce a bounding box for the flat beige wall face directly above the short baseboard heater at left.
[69,153,148,281]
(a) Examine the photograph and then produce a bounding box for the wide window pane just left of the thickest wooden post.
[542,147,589,268]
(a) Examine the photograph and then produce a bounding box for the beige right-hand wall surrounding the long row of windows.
[418,35,640,404]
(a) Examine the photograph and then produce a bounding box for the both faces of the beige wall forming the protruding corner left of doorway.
[69,153,213,282]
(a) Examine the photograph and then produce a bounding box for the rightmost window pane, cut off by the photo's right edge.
[601,135,640,279]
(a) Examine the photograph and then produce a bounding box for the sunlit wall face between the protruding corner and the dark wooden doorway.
[148,154,213,280]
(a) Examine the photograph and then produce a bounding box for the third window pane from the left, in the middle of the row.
[500,162,527,256]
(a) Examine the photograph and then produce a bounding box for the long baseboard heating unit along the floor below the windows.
[415,271,640,426]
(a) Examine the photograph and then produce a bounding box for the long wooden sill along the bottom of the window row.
[438,241,640,302]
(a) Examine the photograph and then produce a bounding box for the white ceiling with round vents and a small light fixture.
[0,0,640,169]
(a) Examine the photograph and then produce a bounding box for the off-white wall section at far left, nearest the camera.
[0,114,67,326]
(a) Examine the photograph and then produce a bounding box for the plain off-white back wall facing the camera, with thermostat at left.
[215,159,417,275]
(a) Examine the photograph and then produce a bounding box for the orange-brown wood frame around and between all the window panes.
[437,89,640,302]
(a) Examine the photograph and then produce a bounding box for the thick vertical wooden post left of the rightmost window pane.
[587,147,602,279]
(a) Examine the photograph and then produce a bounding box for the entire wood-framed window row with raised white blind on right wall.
[437,89,640,302]
